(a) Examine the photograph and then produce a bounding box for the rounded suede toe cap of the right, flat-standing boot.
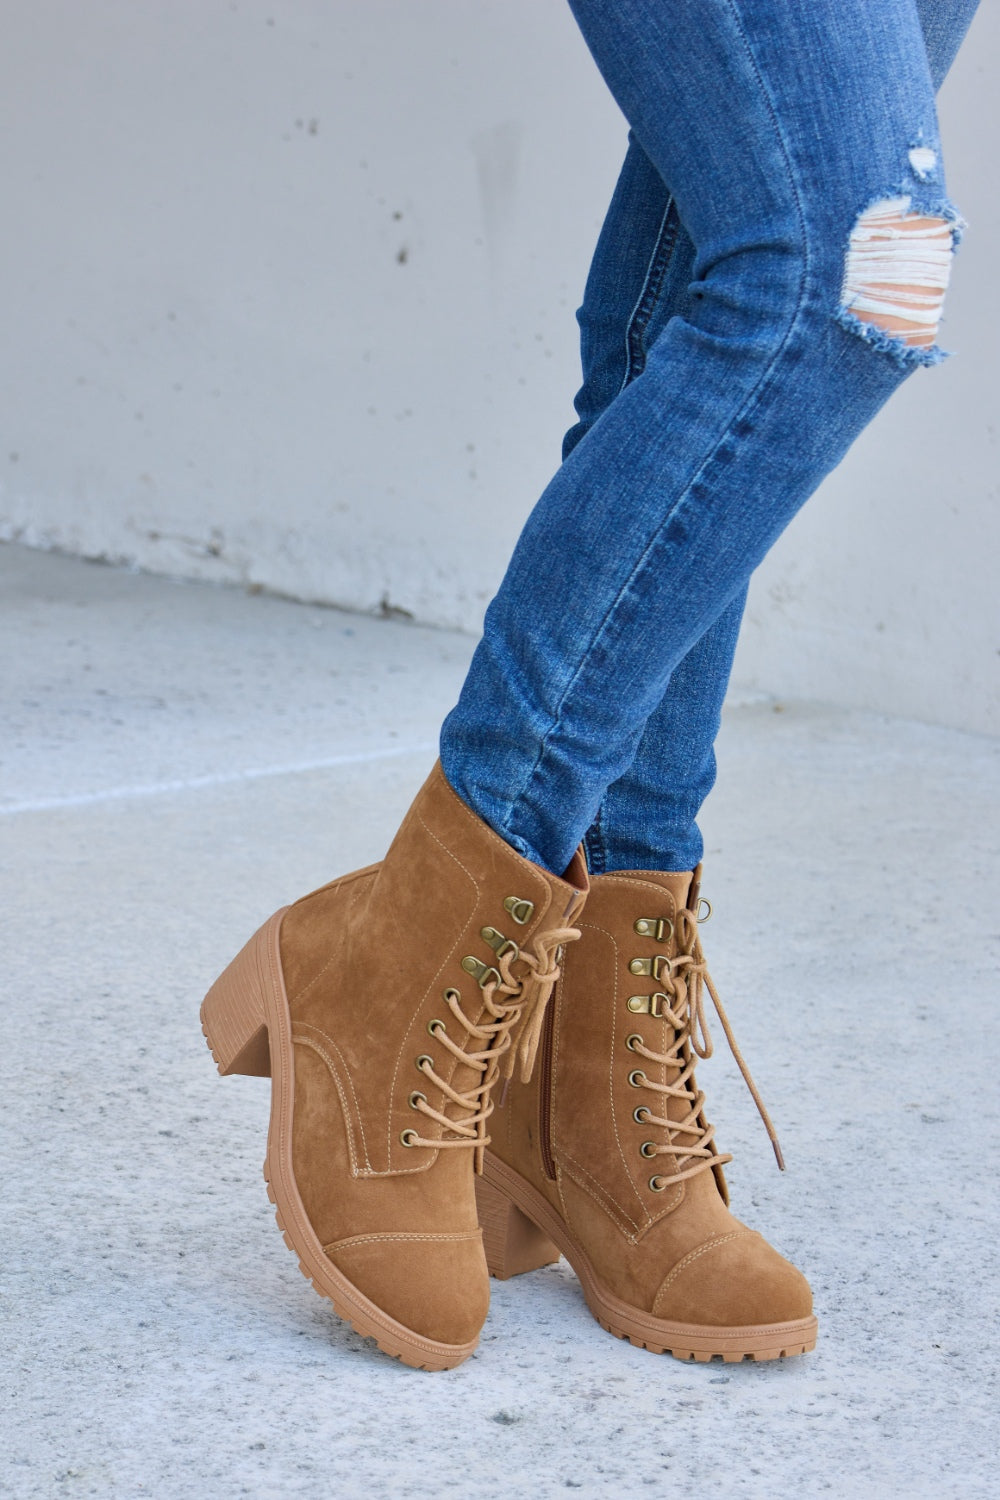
[652,1229,813,1328]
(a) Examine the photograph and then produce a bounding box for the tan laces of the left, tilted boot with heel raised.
[406,927,580,1172]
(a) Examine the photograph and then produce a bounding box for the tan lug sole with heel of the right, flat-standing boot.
[477,1154,817,1364]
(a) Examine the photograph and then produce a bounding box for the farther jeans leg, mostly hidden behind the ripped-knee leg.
[578,0,978,875]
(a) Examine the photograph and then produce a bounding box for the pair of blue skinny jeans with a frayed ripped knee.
[441,0,976,873]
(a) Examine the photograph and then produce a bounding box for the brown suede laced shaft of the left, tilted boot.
[280,767,586,1175]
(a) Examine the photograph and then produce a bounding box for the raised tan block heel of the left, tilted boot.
[201,911,285,1079]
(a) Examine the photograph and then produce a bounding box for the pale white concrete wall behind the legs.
[0,0,1000,729]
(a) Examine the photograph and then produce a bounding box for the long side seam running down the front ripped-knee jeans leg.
[498,0,811,858]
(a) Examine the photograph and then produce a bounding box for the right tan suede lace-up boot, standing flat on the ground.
[477,869,816,1361]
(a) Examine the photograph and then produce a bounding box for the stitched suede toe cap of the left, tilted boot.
[325,1232,490,1349]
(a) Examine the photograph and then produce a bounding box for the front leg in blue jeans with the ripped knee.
[442,0,954,869]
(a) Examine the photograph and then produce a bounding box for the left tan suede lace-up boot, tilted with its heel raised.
[202,767,588,1370]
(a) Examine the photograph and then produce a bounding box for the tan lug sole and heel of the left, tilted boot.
[201,908,478,1371]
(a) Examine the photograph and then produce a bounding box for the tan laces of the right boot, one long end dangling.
[631,909,784,1187]
